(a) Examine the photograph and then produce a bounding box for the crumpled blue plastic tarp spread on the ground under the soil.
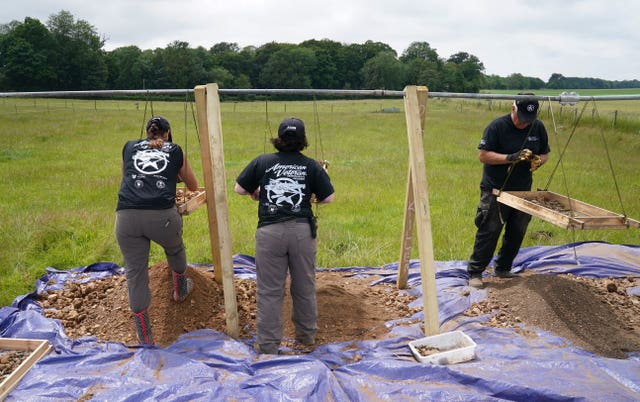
[0,242,640,401]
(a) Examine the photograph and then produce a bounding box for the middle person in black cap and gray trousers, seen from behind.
[235,117,334,354]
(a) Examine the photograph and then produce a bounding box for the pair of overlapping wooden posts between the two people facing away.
[194,84,240,338]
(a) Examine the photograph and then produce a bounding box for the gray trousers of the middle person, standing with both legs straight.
[256,219,318,354]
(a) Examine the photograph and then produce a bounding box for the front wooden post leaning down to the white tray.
[403,86,440,336]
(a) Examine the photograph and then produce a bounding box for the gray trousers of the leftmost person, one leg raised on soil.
[115,207,187,313]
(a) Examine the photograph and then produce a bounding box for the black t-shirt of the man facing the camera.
[478,114,550,191]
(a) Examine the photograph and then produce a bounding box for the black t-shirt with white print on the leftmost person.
[116,139,184,210]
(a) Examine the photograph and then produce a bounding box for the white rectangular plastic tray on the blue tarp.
[409,331,476,364]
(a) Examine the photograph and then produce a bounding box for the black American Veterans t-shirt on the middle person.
[236,152,334,227]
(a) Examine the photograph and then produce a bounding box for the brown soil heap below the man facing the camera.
[465,272,640,359]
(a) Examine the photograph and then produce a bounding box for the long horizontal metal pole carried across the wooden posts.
[0,88,640,104]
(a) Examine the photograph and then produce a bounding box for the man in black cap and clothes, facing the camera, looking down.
[467,93,550,288]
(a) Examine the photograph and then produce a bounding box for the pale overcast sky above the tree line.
[5,0,640,82]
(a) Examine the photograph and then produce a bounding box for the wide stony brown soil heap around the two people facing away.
[39,262,419,351]
